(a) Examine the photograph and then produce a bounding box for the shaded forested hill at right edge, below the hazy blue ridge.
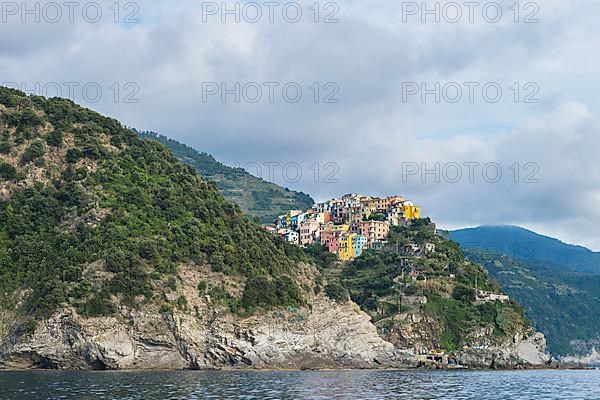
[463,249,600,356]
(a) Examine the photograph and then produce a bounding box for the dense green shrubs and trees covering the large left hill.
[0,88,306,317]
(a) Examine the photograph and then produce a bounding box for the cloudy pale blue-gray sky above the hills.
[0,0,600,250]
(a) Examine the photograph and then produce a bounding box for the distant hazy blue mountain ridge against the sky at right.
[450,225,600,274]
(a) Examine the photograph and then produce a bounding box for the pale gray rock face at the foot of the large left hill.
[0,297,412,369]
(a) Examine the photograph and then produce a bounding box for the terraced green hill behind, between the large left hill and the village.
[140,132,314,223]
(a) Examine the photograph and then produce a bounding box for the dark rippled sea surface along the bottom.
[0,370,600,400]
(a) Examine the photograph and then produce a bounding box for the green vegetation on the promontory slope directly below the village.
[340,219,527,351]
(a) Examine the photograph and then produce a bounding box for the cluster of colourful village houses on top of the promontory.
[265,194,421,261]
